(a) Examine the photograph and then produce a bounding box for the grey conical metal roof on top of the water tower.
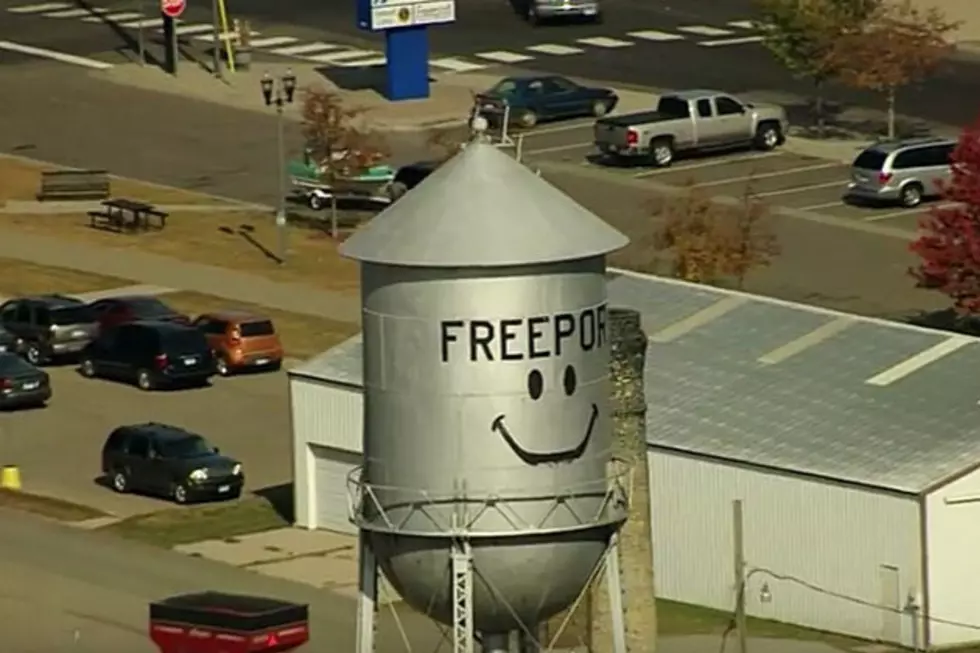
[340,142,629,268]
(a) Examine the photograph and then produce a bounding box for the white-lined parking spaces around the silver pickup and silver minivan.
[521,121,948,230]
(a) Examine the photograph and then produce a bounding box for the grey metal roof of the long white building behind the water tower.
[290,273,980,493]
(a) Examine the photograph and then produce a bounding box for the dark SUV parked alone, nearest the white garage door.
[102,423,245,503]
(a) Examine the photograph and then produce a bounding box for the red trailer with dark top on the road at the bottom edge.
[150,592,310,653]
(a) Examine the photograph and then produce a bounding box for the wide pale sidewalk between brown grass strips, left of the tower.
[0,228,361,324]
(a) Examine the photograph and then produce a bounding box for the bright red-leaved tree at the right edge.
[910,119,980,315]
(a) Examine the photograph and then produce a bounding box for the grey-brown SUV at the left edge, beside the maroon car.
[0,295,99,365]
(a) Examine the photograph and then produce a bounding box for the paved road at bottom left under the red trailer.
[0,510,436,653]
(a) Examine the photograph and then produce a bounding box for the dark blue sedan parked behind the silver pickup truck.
[476,75,619,128]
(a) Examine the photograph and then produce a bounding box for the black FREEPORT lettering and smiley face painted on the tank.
[440,304,608,465]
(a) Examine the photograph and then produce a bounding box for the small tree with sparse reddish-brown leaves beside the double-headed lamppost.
[302,88,388,238]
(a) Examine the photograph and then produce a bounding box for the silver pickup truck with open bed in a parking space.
[595,91,788,167]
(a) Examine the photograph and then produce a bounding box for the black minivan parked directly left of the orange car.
[79,322,217,390]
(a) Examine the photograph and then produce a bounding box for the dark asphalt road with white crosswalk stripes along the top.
[0,0,980,126]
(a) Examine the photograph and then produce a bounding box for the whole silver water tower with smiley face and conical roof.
[341,139,628,653]
